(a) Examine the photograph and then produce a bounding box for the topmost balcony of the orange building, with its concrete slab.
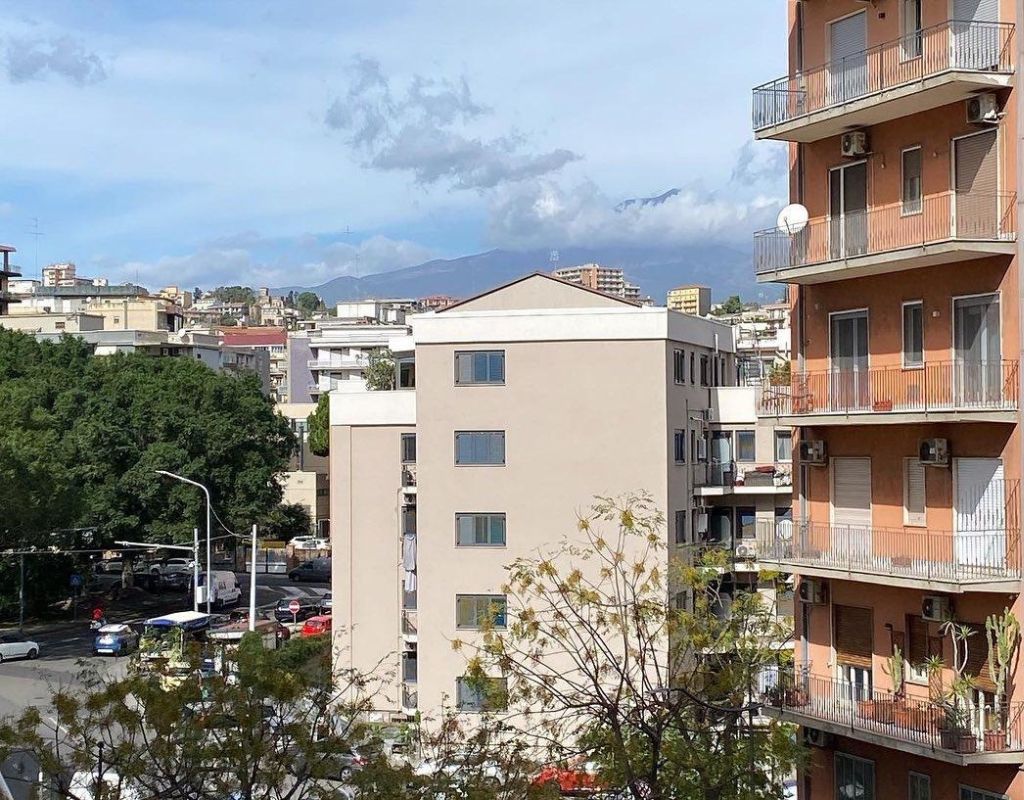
[754,20,1014,142]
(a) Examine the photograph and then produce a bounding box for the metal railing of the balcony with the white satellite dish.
[754,192,1017,276]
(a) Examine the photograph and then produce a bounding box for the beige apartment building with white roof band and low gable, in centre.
[330,273,736,718]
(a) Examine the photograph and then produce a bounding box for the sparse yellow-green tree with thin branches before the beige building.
[455,495,799,800]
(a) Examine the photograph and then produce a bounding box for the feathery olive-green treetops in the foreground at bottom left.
[0,634,552,800]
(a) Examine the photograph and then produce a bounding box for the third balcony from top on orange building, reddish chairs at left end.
[758,361,1019,426]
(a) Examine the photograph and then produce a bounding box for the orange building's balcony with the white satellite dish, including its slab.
[754,192,1017,284]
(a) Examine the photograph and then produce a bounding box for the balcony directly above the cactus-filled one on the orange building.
[757,518,1021,593]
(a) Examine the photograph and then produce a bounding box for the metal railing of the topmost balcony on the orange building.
[754,20,1014,130]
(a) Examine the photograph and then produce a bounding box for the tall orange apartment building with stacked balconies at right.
[754,0,1024,800]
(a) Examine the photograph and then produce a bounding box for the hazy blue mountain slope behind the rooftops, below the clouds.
[272,245,782,304]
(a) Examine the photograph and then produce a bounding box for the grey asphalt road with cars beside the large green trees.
[0,573,330,717]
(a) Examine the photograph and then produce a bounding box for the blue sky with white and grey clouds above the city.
[0,0,785,288]
